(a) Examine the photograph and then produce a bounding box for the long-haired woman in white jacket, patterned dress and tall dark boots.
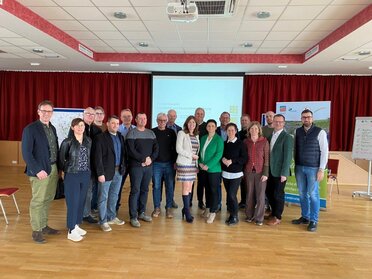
[176,115,199,223]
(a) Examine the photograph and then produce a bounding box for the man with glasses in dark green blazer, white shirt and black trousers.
[266,114,293,226]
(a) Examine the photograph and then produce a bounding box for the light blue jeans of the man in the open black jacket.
[98,171,122,224]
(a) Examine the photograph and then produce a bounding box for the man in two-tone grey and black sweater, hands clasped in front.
[126,113,159,228]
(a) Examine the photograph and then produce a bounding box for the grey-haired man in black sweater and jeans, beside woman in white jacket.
[152,113,177,218]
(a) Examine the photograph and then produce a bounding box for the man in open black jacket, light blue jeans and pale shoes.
[93,115,126,232]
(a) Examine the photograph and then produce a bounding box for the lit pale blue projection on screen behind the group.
[151,75,243,130]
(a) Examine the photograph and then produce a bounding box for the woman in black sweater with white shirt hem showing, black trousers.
[222,123,248,226]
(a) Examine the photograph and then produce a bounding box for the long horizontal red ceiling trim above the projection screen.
[95,53,303,64]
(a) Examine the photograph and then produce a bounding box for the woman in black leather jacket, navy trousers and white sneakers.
[59,118,92,242]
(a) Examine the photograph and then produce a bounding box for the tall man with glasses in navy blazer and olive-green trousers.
[22,101,60,244]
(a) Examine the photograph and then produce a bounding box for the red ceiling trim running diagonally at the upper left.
[0,0,93,59]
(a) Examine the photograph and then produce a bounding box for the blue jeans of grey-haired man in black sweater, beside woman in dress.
[152,162,174,208]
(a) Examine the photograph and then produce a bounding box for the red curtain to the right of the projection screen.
[243,75,372,151]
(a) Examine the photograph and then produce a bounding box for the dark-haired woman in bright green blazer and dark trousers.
[199,119,223,224]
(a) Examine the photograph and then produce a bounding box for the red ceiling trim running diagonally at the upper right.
[304,5,372,60]
